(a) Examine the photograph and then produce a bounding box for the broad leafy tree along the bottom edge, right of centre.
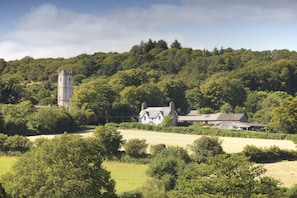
[169,154,285,197]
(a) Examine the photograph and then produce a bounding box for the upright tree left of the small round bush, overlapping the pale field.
[94,126,123,158]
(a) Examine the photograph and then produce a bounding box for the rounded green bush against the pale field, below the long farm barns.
[191,136,224,163]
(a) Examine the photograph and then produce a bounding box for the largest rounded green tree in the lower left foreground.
[3,134,115,198]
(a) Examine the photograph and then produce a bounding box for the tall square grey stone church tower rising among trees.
[58,70,73,107]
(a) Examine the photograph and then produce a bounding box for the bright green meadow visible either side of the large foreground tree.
[0,156,149,194]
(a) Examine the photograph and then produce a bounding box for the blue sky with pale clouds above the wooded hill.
[0,0,297,61]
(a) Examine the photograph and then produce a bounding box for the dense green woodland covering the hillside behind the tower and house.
[0,39,297,133]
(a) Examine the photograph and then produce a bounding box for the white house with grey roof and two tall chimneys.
[138,102,178,126]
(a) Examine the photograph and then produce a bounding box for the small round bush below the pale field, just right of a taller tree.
[124,138,148,158]
